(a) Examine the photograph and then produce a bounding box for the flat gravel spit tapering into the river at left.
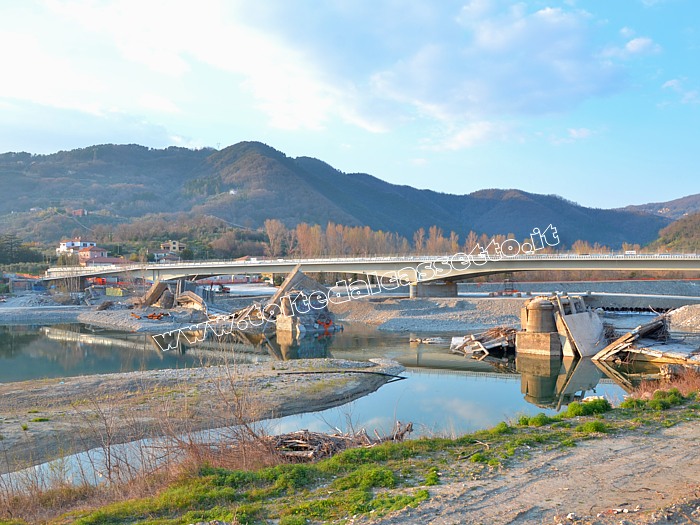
[0,359,403,472]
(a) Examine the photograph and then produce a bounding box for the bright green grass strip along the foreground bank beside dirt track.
[45,390,700,525]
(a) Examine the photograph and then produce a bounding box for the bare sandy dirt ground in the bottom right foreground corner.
[354,420,700,525]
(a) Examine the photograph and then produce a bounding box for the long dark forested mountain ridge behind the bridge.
[0,142,680,247]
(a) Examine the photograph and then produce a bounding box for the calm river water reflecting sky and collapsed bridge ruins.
[0,325,636,435]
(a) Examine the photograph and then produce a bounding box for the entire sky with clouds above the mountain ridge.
[0,0,700,208]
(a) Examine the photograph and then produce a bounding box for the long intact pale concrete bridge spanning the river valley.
[44,253,700,295]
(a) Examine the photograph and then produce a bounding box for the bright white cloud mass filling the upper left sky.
[16,0,384,132]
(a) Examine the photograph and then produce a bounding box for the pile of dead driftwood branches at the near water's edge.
[265,421,413,461]
